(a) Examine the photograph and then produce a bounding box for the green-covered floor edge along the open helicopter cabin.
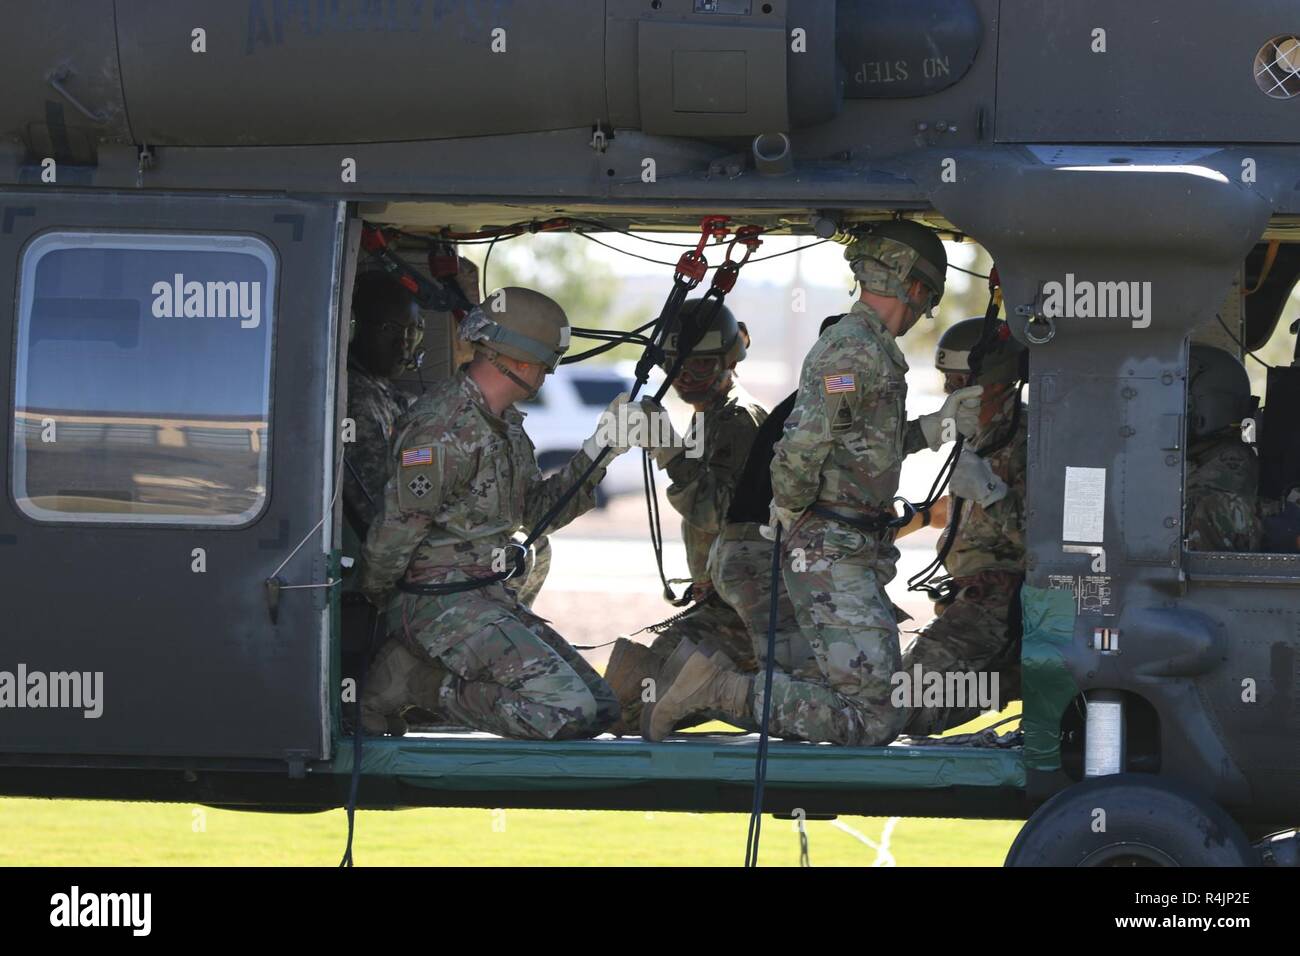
[312,732,1027,819]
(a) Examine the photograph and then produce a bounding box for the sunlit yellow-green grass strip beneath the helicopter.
[0,800,1019,866]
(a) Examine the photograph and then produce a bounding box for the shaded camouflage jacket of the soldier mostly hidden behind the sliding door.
[343,360,415,535]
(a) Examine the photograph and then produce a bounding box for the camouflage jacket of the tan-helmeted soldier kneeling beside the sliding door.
[361,372,605,597]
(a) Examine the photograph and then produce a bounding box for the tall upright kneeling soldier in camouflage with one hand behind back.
[649,221,979,745]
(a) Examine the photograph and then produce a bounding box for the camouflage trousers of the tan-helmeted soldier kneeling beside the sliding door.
[387,584,619,740]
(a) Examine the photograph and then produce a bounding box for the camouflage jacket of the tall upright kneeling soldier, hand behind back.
[772,302,926,511]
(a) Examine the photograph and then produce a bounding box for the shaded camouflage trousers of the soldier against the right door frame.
[902,571,1023,736]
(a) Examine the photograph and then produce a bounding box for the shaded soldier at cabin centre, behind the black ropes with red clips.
[605,299,767,732]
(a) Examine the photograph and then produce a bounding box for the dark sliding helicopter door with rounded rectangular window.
[0,191,345,765]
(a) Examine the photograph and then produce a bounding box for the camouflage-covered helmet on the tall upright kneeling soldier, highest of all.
[844,220,948,312]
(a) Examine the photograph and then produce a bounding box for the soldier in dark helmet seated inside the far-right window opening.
[1184,343,1264,551]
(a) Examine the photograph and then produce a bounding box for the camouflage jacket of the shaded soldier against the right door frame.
[939,398,1030,578]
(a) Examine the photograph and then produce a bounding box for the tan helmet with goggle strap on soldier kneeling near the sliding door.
[460,286,569,372]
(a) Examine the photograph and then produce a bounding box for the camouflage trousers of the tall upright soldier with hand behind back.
[754,514,907,747]
